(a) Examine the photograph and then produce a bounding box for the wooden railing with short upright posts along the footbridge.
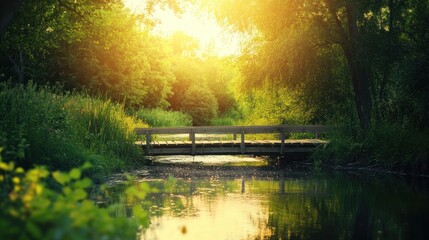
[135,125,331,154]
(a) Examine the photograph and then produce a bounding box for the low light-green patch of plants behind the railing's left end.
[134,108,192,127]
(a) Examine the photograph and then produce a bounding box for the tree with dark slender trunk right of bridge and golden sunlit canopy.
[202,0,400,130]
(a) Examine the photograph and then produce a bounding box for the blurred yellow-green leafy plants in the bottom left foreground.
[0,149,151,239]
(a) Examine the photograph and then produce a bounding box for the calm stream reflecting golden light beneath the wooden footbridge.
[103,156,429,240]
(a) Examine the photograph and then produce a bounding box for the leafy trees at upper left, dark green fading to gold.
[0,0,174,107]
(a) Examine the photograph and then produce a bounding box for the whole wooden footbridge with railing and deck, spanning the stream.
[136,125,329,155]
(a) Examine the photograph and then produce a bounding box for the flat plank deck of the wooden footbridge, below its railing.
[137,139,327,155]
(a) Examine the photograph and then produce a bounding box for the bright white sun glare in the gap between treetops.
[124,0,245,56]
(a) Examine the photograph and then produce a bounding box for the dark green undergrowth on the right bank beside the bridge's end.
[312,123,429,174]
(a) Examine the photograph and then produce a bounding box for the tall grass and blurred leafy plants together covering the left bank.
[0,83,150,239]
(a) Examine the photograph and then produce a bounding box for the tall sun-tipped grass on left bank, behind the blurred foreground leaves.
[0,83,142,180]
